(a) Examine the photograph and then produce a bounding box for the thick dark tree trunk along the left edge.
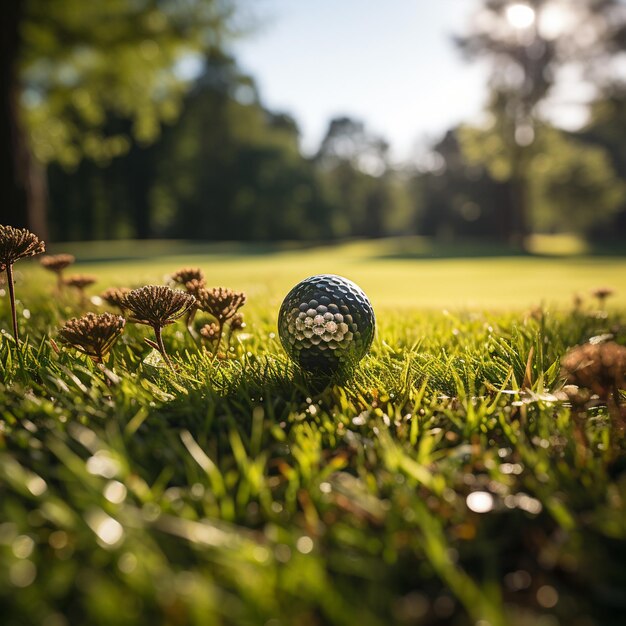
[0,0,47,239]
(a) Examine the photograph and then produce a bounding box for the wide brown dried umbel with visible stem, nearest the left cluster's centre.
[123,285,196,369]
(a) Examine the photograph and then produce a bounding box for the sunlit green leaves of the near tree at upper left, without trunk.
[20,0,233,167]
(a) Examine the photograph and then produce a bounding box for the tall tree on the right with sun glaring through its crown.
[457,0,626,245]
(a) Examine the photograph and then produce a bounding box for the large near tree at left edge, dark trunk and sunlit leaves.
[0,0,234,235]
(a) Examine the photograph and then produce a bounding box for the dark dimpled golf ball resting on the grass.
[278,274,376,374]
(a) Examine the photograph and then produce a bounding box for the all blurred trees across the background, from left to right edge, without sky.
[7,0,626,245]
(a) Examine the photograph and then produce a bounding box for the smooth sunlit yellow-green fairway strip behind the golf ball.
[46,239,626,311]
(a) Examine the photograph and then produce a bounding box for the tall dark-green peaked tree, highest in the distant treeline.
[140,53,332,241]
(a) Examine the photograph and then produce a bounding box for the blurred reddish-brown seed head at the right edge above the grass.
[561,341,626,399]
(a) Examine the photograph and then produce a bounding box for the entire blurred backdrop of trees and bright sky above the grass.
[0,0,626,251]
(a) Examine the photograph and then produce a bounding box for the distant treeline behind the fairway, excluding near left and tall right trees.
[48,54,626,241]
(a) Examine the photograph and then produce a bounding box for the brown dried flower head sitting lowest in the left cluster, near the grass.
[59,313,126,363]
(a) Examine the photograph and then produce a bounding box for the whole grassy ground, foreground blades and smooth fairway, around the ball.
[0,242,626,626]
